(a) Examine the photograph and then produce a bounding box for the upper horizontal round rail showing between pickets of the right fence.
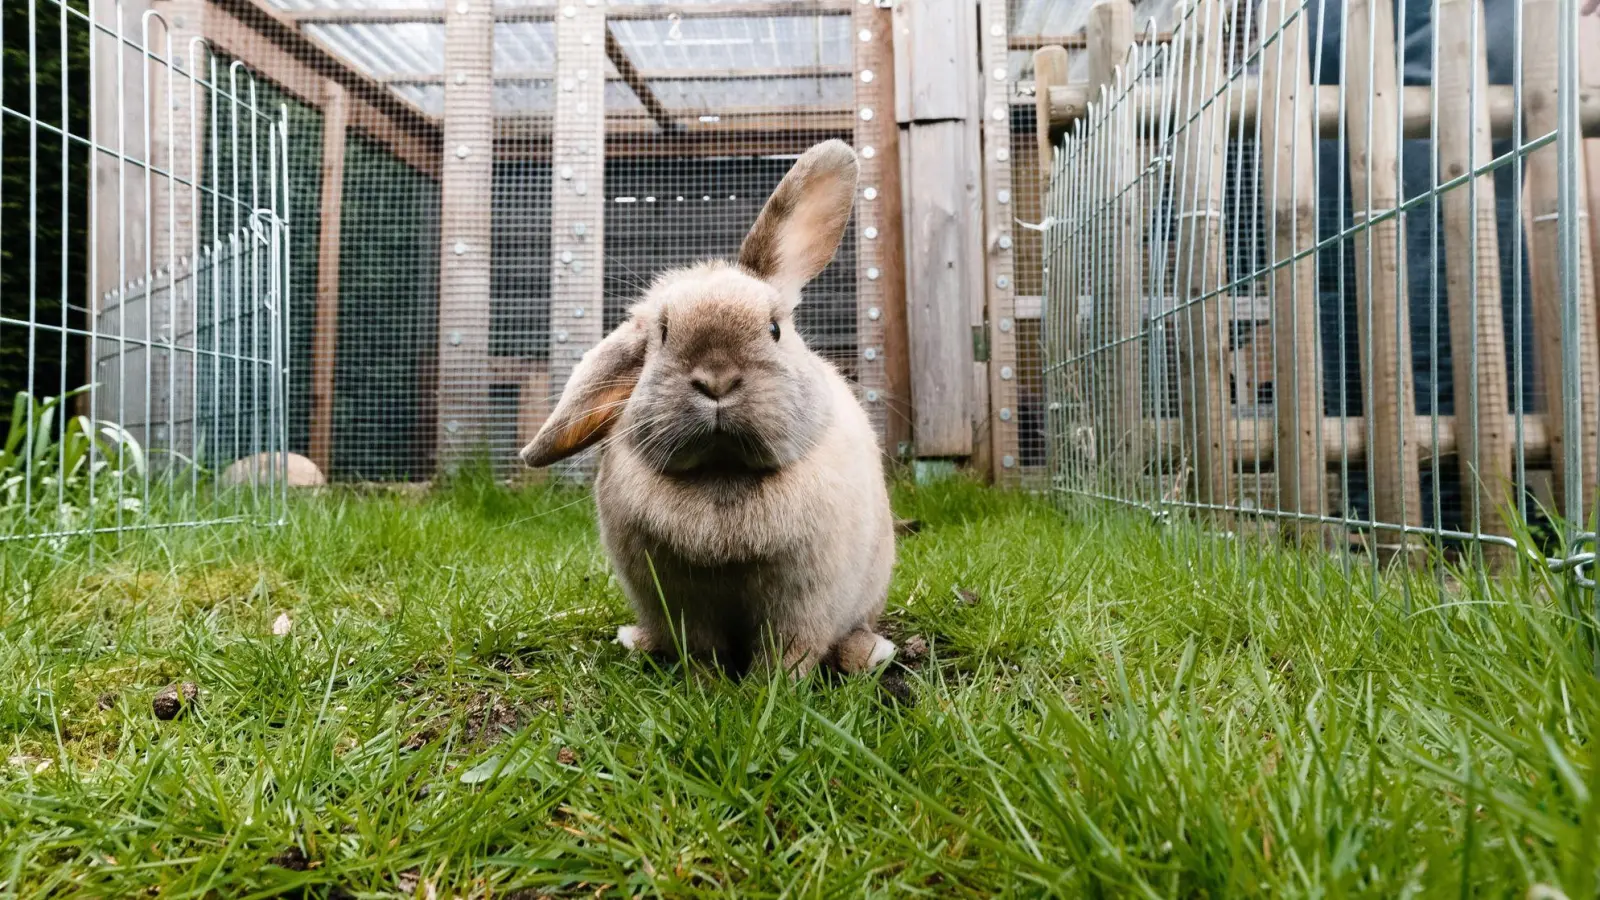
[1034,80,1600,139]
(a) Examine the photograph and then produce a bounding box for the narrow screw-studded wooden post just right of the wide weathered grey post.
[978,0,1022,485]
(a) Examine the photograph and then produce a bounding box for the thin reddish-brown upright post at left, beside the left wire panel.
[307,80,349,477]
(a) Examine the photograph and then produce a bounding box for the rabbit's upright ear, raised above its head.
[739,141,856,293]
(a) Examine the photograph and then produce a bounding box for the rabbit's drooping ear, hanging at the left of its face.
[520,319,645,468]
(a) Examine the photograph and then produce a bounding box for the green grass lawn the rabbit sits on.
[0,484,1600,898]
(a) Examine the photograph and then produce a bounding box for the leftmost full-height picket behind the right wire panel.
[1174,0,1234,504]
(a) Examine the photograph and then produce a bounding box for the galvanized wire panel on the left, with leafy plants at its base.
[0,0,290,543]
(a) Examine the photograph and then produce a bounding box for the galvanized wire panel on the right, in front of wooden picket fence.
[1043,0,1600,557]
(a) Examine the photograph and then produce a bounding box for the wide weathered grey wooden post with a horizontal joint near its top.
[894,0,987,456]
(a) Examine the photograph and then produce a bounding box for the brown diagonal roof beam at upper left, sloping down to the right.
[206,0,440,178]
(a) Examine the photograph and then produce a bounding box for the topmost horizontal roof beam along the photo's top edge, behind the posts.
[292,0,854,26]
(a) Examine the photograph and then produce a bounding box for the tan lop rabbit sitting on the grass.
[522,141,894,677]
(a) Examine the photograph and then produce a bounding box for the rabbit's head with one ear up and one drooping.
[522,141,856,472]
